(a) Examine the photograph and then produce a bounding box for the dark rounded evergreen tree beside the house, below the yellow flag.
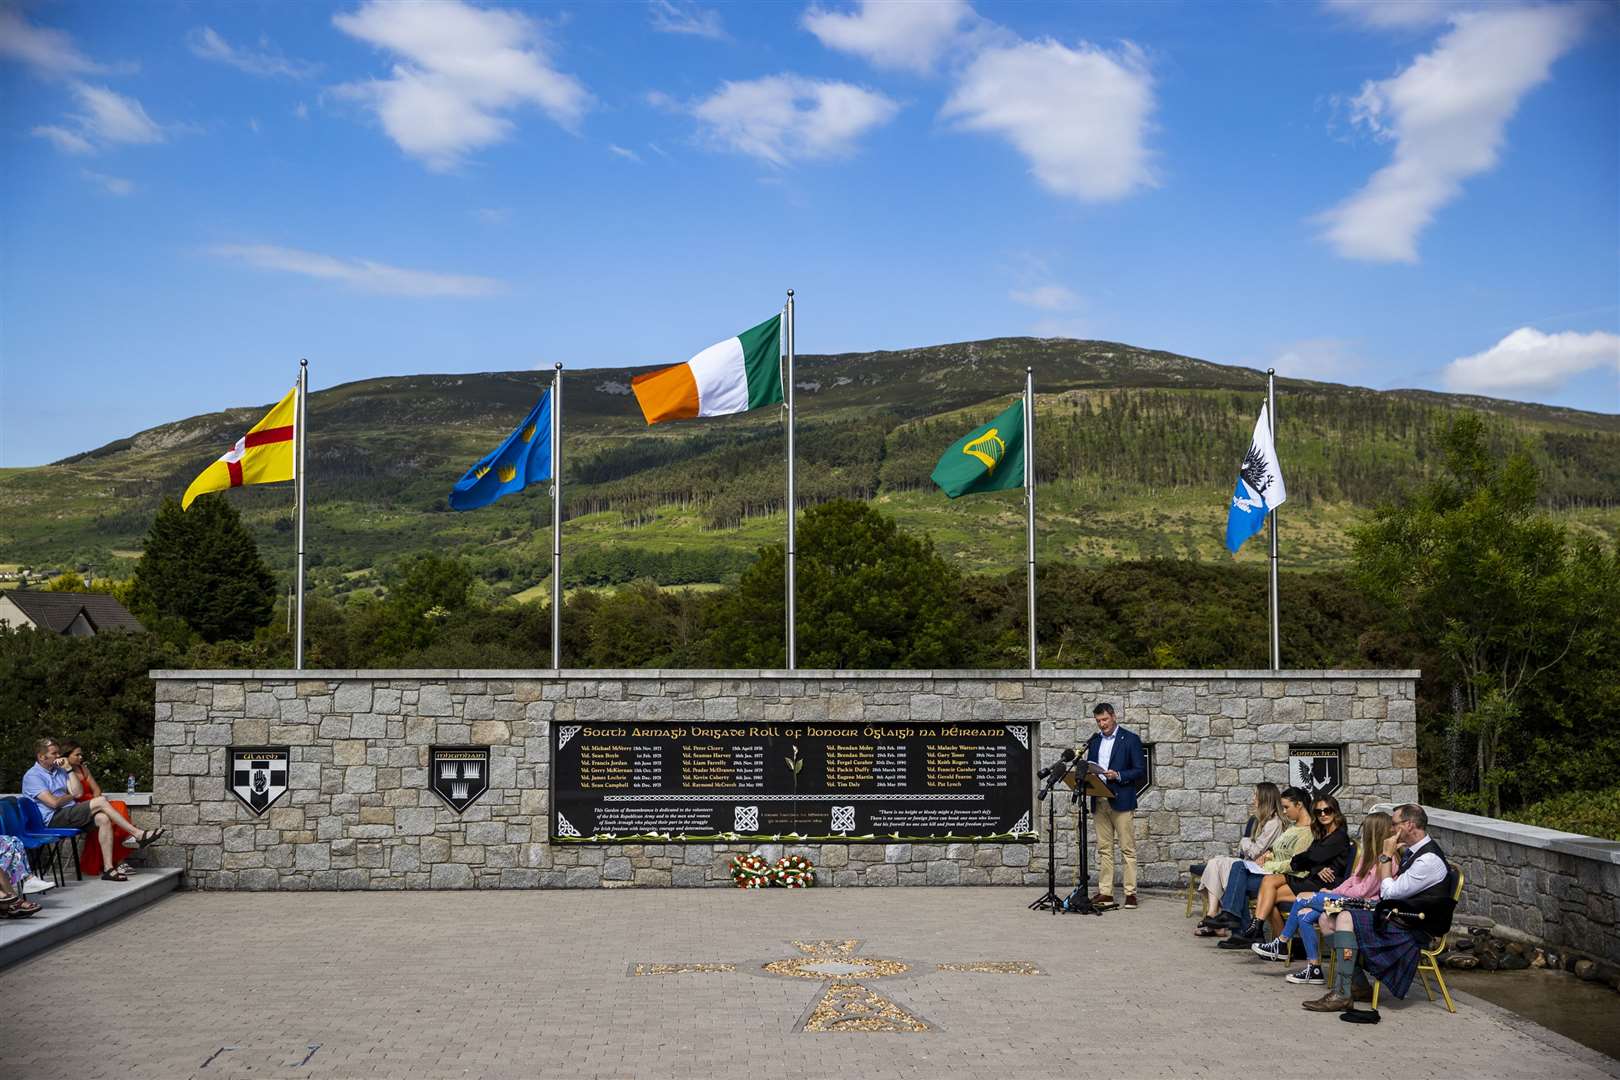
[131,495,275,641]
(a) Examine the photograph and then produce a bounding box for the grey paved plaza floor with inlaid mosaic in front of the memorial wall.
[0,889,1620,1080]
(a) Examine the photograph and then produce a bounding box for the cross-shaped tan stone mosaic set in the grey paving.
[630,938,1043,1031]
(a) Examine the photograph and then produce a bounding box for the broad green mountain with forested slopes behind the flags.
[0,338,1620,597]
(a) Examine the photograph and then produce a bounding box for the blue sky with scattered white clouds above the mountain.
[0,0,1620,466]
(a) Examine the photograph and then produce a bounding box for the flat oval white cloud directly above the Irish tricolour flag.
[692,74,899,165]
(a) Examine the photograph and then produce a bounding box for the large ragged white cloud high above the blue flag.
[332,0,590,170]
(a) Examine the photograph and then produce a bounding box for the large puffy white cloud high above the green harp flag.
[941,40,1153,202]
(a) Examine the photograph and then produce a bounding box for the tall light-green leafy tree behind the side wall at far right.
[1354,415,1620,814]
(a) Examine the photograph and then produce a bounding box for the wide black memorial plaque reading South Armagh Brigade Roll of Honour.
[551,722,1035,844]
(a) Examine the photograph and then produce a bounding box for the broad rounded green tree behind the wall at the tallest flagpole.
[710,500,972,669]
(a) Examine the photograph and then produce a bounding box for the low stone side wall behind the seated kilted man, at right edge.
[1424,806,1620,965]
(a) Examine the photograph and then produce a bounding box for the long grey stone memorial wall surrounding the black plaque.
[152,670,1418,889]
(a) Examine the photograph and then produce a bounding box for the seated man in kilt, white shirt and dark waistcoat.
[1304,803,1456,1023]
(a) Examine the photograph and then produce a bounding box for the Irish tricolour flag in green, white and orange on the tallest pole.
[630,316,782,424]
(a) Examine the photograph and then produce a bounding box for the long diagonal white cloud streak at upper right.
[1317,5,1586,262]
